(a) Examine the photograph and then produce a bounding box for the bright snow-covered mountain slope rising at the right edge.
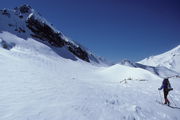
[138,45,180,73]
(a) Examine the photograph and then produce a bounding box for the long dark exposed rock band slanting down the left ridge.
[26,12,90,62]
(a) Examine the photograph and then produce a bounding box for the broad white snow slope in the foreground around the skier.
[0,32,180,120]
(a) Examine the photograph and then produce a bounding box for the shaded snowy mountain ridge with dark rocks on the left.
[0,5,104,63]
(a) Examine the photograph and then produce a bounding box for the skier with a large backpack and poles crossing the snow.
[158,78,173,106]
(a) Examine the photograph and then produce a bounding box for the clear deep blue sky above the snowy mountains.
[0,0,180,61]
